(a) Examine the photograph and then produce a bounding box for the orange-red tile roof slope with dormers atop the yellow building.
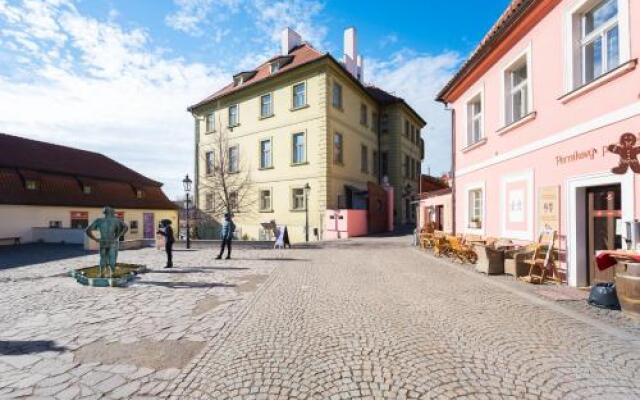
[188,43,328,111]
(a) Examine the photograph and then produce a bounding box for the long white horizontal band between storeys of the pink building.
[456,102,640,177]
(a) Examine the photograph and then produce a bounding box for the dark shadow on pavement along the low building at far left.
[0,243,96,269]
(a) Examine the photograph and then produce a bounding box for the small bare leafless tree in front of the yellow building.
[198,119,255,217]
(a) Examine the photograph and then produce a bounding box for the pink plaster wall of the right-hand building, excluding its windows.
[450,0,640,283]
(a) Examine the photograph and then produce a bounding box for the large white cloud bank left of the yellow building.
[0,0,228,197]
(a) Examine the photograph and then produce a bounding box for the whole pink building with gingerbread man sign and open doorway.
[438,0,640,286]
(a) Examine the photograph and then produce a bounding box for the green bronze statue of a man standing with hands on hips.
[85,207,129,277]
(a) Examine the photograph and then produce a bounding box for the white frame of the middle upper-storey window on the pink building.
[500,43,535,127]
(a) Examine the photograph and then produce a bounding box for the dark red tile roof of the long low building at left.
[0,134,176,210]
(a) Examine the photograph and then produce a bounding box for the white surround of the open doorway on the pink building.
[566,171,635,286]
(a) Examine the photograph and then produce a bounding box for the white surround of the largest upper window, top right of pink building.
[563,0,631,93]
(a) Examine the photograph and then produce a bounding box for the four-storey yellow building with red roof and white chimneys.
[189,28,426,241]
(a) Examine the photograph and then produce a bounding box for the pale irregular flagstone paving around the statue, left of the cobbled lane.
[0,246,286,399]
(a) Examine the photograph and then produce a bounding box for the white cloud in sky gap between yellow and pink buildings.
[365,50,462,175]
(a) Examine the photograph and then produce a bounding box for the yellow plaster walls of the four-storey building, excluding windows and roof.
[192,60,422,242]
